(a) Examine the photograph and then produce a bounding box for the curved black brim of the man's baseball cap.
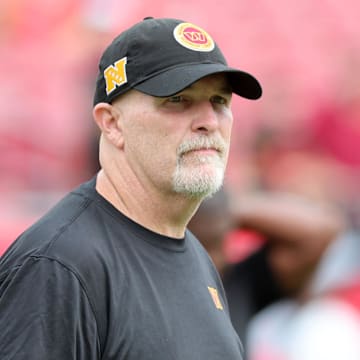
[134,64,262,100]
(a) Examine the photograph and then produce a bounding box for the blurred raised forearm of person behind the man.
[232,192,346,246]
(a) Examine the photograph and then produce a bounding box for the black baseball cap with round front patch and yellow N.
[94,17,262,105]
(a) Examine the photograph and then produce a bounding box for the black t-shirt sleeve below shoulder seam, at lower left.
[0,257,100,360]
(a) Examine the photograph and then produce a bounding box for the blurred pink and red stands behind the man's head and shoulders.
[0,0,360,254]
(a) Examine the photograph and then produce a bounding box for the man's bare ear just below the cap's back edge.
[93,103,124,148]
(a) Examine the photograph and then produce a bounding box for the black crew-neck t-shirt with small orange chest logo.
[0,179,242,360]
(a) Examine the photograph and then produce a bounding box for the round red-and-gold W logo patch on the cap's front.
[174,23,215,51]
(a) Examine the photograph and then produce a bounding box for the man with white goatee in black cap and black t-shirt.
[0,18,261,360]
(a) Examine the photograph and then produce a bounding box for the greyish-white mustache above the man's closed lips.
[177,135,228,156]
